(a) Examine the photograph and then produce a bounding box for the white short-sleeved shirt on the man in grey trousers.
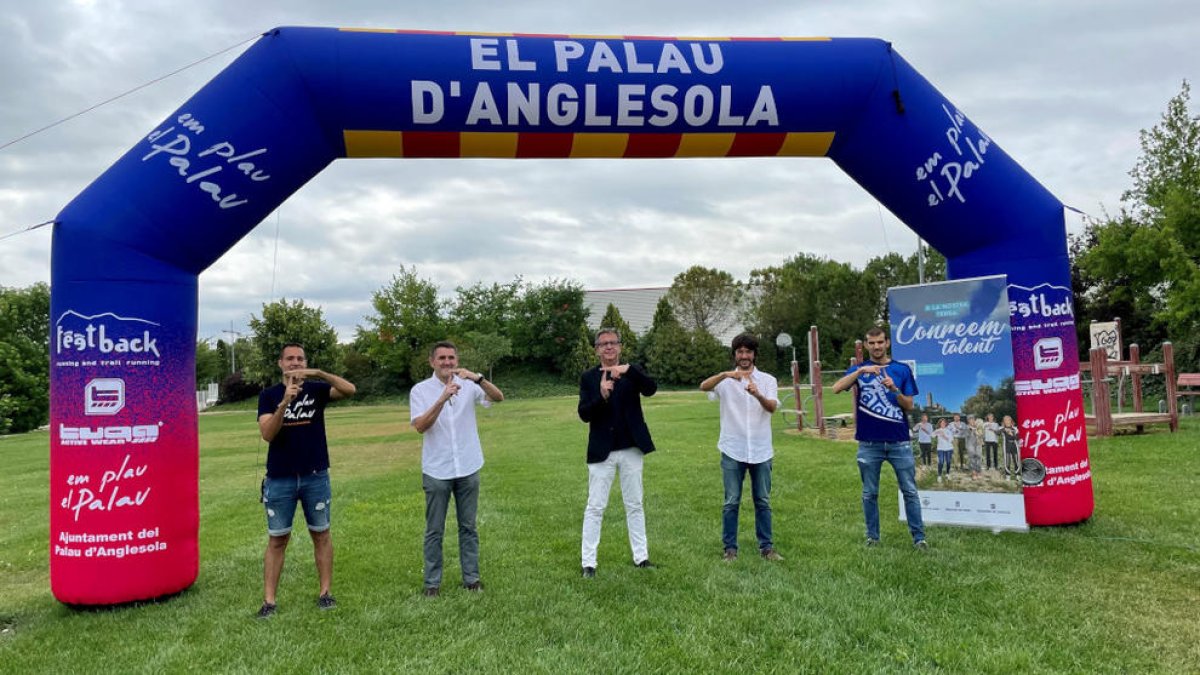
[408,376,492,480]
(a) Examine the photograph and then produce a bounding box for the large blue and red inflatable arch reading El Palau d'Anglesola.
[49,28,1093,604]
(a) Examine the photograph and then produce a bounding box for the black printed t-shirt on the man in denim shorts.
[258,382,332,478]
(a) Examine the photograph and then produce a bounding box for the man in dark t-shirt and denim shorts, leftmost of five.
[258,342,355,619]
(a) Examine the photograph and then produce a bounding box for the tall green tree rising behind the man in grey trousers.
[356,267,446,384]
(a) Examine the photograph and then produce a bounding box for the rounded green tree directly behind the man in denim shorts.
[244,299,342,386]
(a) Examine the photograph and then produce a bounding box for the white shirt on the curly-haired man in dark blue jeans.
[708,368,779,464]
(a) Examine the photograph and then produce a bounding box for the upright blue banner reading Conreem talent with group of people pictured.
[888,276,1028,530]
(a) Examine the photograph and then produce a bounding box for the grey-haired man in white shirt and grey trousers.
[408,341,504,597]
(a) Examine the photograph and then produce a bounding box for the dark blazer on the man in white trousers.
[580,364,659,464]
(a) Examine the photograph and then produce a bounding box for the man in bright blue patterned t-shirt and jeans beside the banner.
[833,327,928,549]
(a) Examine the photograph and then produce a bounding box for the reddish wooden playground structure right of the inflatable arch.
[1079,342,1188,436]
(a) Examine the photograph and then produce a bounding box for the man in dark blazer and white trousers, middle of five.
[580,328,659,577]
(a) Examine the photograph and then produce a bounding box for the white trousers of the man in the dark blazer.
[582,448,650,567]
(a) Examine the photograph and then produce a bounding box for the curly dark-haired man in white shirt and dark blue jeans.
[700,333,784,562]
